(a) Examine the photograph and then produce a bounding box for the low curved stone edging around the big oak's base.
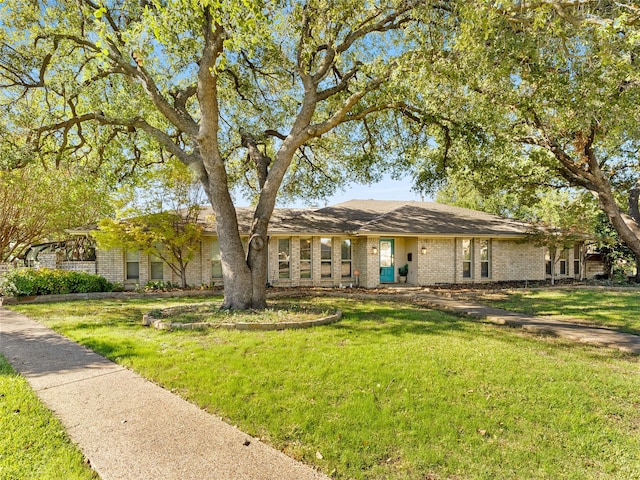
[142,304,342,331]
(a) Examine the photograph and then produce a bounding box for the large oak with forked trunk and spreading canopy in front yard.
[0,0,453,309]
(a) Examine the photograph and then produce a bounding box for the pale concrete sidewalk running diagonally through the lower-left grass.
[0,307,328,480]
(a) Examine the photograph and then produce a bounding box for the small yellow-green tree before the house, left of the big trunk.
[94,206,202,287]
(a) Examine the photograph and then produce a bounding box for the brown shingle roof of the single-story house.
[199,200,527,236]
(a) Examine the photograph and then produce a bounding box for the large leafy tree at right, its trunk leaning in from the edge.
[423,0,640,257]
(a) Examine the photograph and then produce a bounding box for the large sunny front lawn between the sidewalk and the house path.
[12,299,640,480]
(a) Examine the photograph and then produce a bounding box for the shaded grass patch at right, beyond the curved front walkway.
[478,288,640,335]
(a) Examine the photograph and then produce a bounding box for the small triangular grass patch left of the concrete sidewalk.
[0,356,98,480]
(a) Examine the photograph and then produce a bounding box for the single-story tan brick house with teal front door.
[52,200,584,288]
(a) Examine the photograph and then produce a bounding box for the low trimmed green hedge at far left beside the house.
[0,268,113,297]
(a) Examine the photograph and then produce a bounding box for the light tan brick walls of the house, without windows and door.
[95,236,552,288]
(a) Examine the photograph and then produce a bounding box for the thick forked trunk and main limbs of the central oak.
[192,14,319,310]
